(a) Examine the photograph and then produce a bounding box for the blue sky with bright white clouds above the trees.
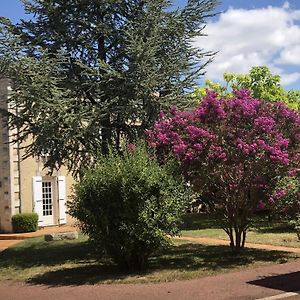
[0,0,300,89]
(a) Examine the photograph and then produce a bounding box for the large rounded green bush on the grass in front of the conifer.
[69,146,186,269]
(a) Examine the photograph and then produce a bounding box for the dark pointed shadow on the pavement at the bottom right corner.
[247,271,300,292]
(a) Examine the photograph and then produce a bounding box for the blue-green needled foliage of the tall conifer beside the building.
[0,0,217,175]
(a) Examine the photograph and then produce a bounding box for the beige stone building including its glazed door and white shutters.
[0,79,74,232]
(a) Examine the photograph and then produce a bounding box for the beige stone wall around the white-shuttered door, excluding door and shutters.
[0,80,74,232]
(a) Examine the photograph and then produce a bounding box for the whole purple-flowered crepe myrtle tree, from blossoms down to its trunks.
[146,90,300,252]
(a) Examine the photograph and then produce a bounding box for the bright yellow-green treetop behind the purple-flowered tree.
[192,66,300,110]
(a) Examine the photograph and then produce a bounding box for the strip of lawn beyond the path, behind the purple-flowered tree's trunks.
[182,214,300,248]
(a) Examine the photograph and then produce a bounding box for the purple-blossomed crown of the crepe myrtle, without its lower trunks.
[146,90,300,202]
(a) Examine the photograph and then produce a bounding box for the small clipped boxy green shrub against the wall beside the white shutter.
[12,213,39,233]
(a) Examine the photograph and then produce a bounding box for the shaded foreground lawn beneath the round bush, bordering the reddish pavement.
[0,236,298,286]
